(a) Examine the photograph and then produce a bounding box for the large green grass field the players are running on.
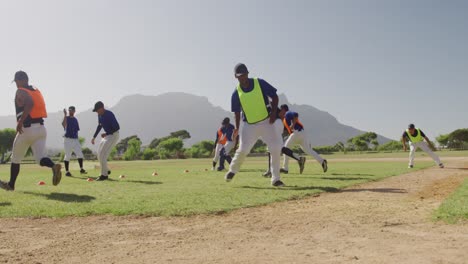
[0,158,433,217]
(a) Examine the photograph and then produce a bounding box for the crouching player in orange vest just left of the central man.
[212,117,235,171]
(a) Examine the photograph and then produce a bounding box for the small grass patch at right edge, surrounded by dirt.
[434,179,468,223]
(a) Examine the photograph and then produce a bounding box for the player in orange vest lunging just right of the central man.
[280,104,328,174]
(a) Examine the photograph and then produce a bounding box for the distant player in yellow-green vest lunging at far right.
[401,124,444,168]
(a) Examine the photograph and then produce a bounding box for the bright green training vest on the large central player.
[237,78,268,124]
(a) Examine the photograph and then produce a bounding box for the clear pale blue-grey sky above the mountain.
[0,0,468,139]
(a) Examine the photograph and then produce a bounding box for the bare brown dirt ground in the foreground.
[0,158,468,264]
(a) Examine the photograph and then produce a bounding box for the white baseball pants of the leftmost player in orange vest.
[11,124,47,164]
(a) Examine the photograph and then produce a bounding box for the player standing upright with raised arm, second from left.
[62,106,87,176]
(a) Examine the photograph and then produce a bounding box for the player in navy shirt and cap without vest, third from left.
[91,101,120,181]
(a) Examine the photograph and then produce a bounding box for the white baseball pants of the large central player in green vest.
[229,119,283,183]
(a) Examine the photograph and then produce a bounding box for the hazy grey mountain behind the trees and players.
[0,93,389,149]
